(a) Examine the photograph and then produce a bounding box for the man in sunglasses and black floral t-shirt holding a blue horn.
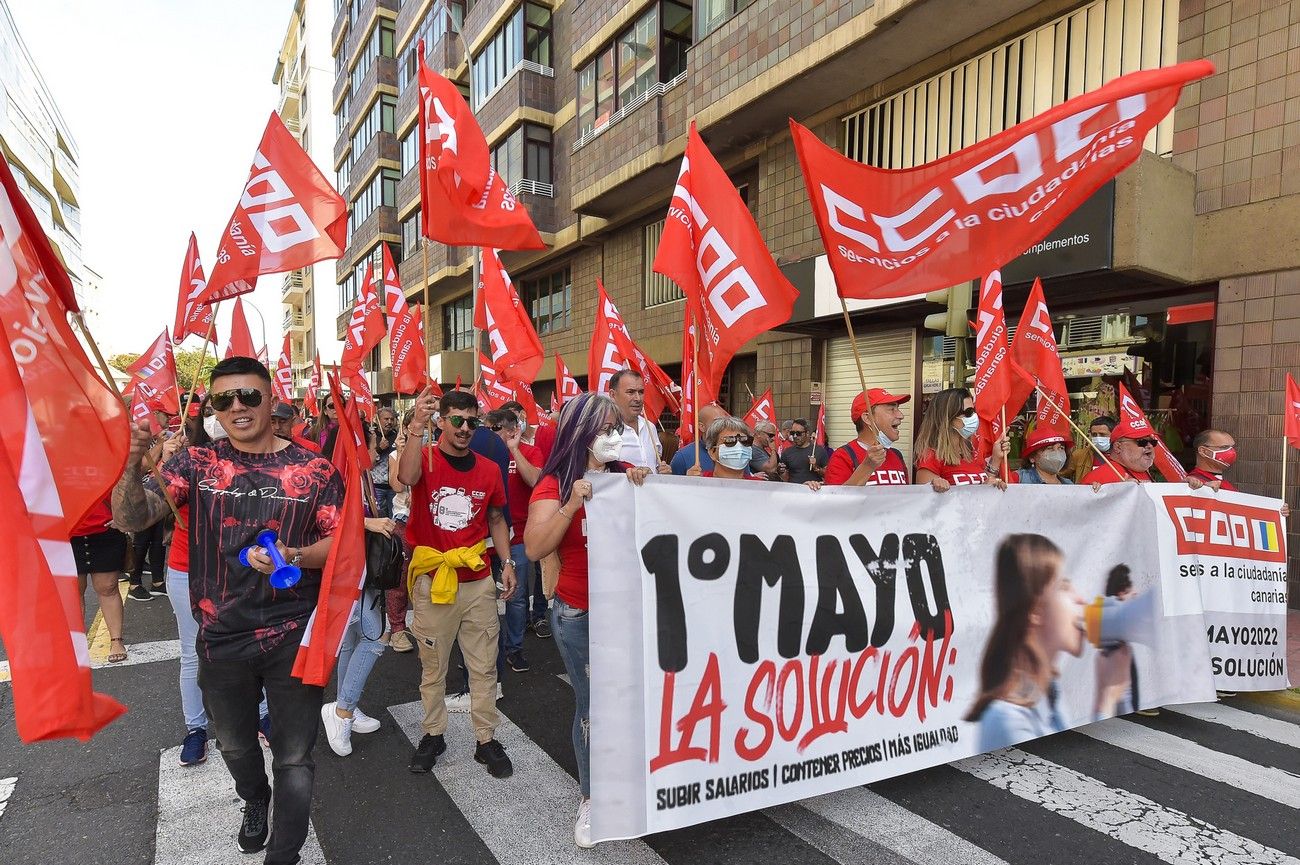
[113,356,343,865]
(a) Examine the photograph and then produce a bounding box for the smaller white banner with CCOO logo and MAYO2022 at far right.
[1144,484,1288,691]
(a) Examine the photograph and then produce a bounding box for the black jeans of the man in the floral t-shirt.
[199,640,322,865]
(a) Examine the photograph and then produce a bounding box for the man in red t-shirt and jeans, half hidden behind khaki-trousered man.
[488,402,542,672]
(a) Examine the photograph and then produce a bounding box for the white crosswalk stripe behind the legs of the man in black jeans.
[153,741,325,865]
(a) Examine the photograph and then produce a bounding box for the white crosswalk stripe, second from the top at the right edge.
[1075,718,1300,808]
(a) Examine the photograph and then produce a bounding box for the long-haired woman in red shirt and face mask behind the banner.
[915,388,1010,493]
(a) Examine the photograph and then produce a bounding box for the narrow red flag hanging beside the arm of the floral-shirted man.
[293,379,369,685]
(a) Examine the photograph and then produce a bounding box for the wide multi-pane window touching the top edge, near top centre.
[577,0,692,135]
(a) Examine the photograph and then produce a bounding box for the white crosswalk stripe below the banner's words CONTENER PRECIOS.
[763,787,1006,865]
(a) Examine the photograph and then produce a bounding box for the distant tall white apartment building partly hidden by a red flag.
[268,0,341,397]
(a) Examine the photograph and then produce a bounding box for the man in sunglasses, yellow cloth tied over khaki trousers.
[398,388,516,778]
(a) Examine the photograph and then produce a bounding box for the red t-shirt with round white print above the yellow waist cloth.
[407,446,506,583]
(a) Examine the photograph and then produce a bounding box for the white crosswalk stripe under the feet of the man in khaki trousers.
[389,701,663,865]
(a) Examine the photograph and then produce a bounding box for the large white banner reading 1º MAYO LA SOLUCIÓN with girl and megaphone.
[586,476,1248,840]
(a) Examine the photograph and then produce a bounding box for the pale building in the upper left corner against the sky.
[0,0,83,297]
